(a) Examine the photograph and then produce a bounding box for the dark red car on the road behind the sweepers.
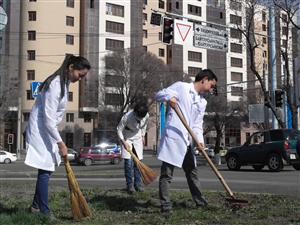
[77,144,121,166]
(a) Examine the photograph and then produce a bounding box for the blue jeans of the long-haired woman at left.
[32,169,52,214]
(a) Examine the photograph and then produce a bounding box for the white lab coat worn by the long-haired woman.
[25,76,69,171]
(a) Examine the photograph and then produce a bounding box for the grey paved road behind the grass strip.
[0,155,300,197]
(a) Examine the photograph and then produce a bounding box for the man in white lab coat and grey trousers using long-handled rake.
[155,69,218,215]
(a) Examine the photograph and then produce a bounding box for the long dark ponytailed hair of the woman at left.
[39,54,91,98]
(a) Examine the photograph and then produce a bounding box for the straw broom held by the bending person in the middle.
[126,146,157,185]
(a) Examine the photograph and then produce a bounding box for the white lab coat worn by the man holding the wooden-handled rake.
[155,82,207,168]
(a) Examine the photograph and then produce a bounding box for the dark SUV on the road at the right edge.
[225,129,300,171]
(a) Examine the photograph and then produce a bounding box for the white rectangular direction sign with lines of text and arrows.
[194,24,228,52]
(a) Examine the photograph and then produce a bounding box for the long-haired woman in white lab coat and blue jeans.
[25,55,91,215]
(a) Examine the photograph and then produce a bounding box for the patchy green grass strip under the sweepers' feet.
[0,189,300,225]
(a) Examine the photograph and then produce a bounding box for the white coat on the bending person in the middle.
[117,110,149,160]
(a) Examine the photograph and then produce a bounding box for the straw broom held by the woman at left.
[63,156,92,220]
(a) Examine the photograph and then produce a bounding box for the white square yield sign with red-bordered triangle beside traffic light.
[174,20,193,45]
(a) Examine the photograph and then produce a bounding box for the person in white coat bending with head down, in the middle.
[117,99,149,194]
